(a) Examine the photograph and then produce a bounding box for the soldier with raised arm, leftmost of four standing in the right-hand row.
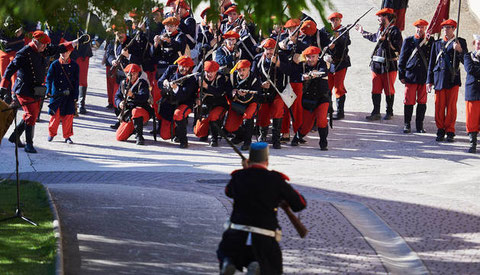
[355,8,402,121]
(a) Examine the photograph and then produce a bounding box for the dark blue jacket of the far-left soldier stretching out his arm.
[2,42,67,97]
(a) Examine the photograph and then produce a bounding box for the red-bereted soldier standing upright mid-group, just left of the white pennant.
[252,38,288,149]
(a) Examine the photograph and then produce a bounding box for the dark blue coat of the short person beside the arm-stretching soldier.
[47,59,79,116]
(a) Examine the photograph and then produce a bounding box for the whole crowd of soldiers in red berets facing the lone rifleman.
[0,0,478,155]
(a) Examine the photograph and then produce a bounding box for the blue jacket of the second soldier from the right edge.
[427,37,468,90]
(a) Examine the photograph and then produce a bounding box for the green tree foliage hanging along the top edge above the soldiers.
[0,0,333,34]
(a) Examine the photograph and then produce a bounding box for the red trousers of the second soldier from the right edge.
[435,86,459,133]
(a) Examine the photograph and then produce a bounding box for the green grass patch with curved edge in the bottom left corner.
[0,181,56,275]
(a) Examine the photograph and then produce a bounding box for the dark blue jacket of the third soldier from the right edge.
[398,36,434,84]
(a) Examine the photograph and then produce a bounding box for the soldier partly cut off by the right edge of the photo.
[463,34,480,153]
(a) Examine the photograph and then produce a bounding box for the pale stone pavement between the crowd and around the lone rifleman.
[0,0,480,274]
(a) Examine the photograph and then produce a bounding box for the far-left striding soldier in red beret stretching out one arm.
[0,31,79,153]
